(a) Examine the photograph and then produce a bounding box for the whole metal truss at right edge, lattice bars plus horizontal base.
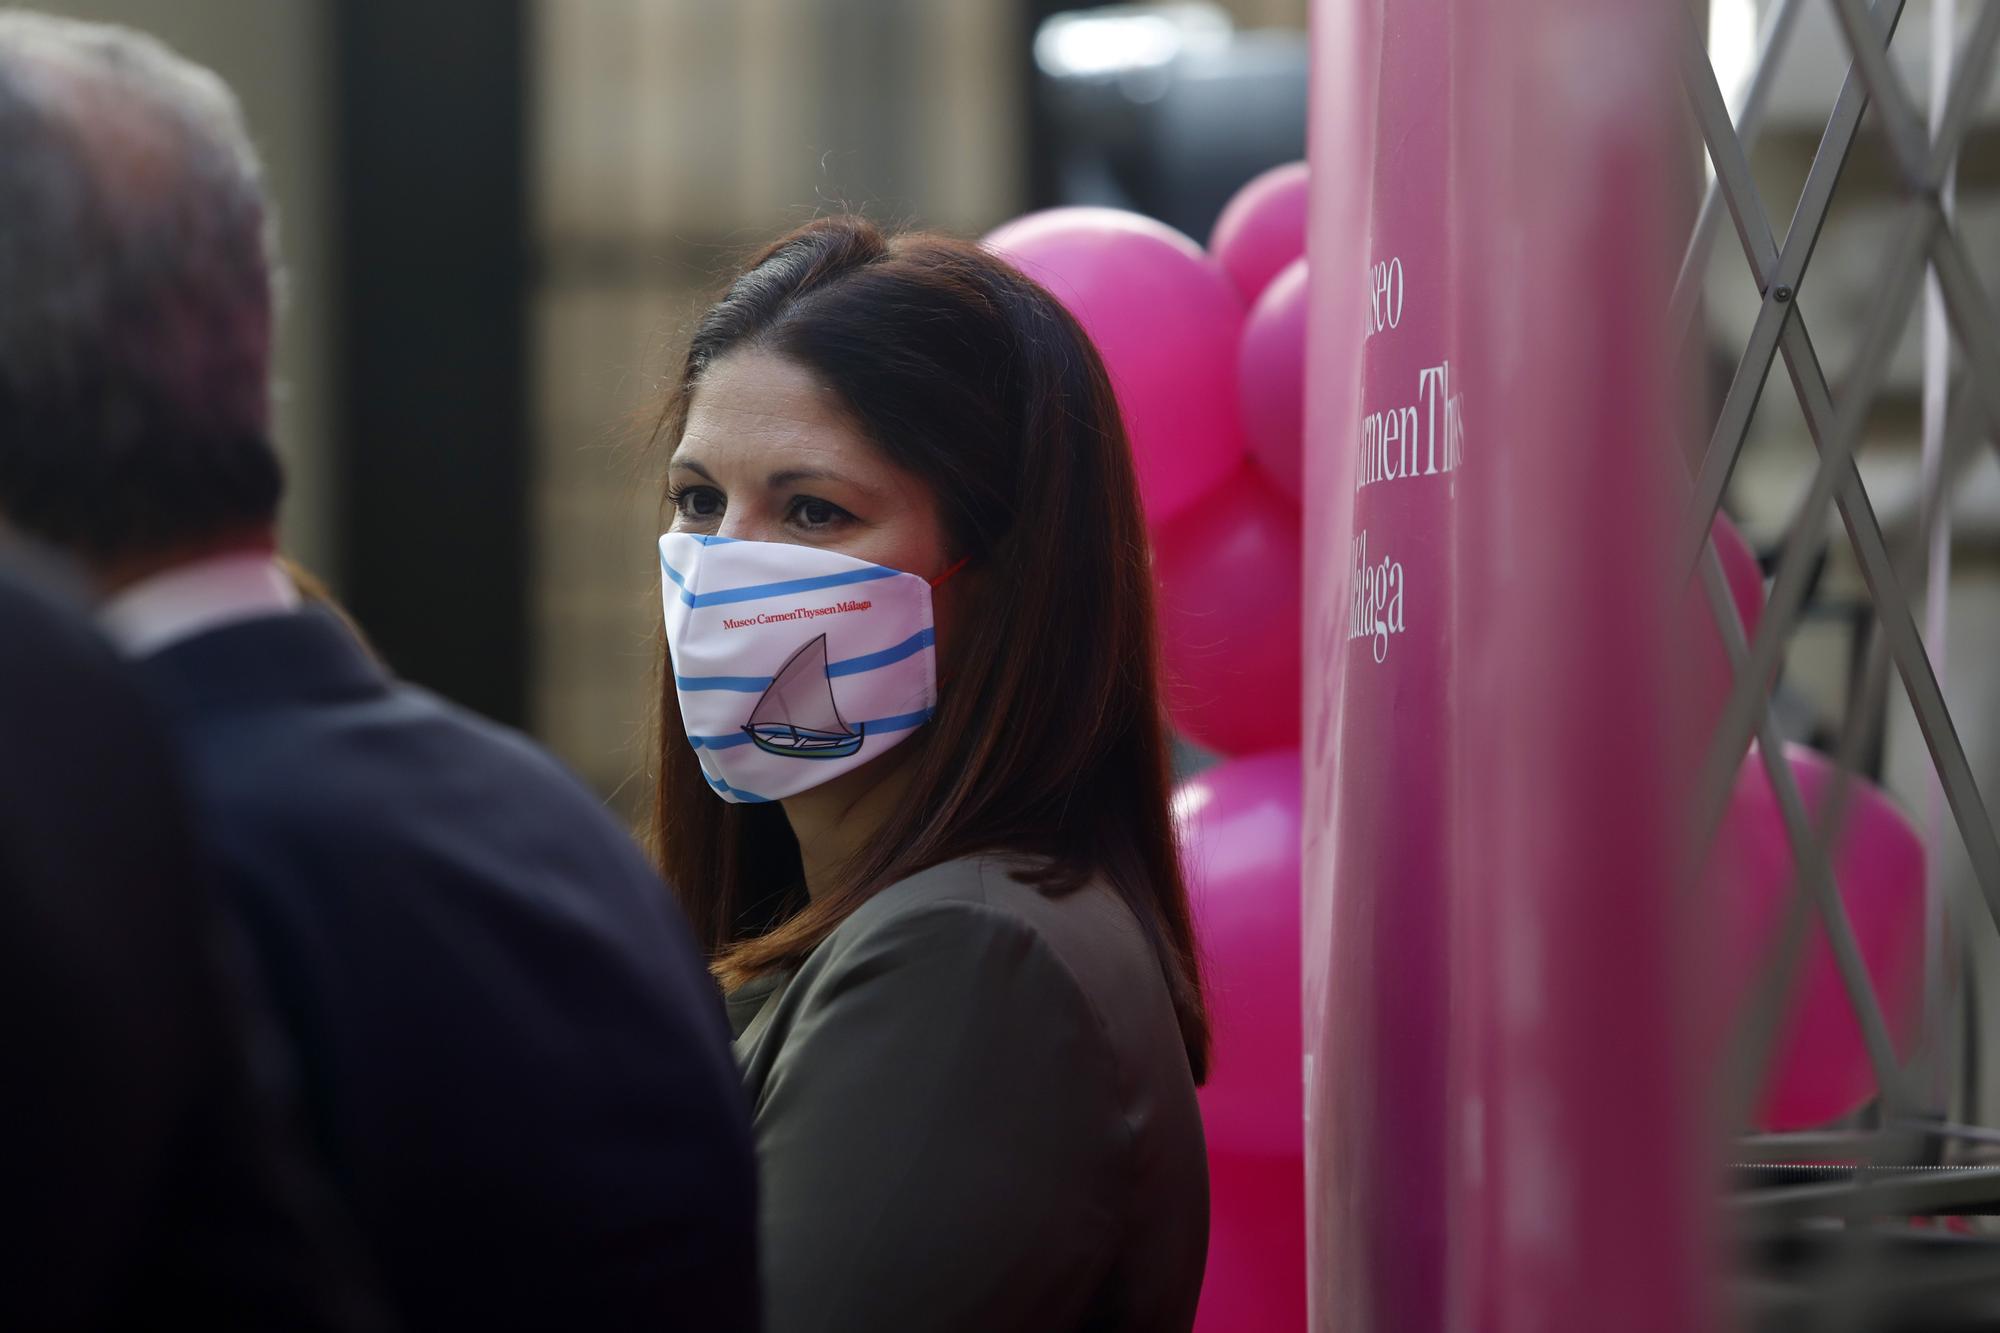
[1670,0,2000,1329]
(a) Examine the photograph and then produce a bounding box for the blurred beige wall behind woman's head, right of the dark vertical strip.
[530,0,1028,808]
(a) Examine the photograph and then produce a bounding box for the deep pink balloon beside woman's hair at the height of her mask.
[1154,466,1302,755]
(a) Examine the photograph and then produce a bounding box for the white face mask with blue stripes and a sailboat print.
[660,532,956,803]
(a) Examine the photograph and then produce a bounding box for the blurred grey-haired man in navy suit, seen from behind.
[0,12,756,1329]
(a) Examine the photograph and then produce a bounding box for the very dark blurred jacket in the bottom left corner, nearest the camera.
[0,570,382,1331]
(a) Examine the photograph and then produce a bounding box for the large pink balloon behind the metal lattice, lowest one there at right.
[1712,745,1924,1131]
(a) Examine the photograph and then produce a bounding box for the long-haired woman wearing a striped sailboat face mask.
[656,218,1208,1333]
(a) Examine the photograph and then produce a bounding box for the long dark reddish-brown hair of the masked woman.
[652,216,1208,1081]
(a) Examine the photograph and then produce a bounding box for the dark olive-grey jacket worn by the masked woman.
[730,857,1208,1333]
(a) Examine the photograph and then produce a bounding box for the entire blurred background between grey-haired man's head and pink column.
[42,0,1308,815]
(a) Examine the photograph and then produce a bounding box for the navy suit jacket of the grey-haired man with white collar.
[142,610,758,1329]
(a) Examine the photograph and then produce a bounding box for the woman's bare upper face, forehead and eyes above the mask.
[666,350,956,580]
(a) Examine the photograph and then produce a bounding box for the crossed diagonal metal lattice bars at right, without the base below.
[1670,0,2000,1160]
